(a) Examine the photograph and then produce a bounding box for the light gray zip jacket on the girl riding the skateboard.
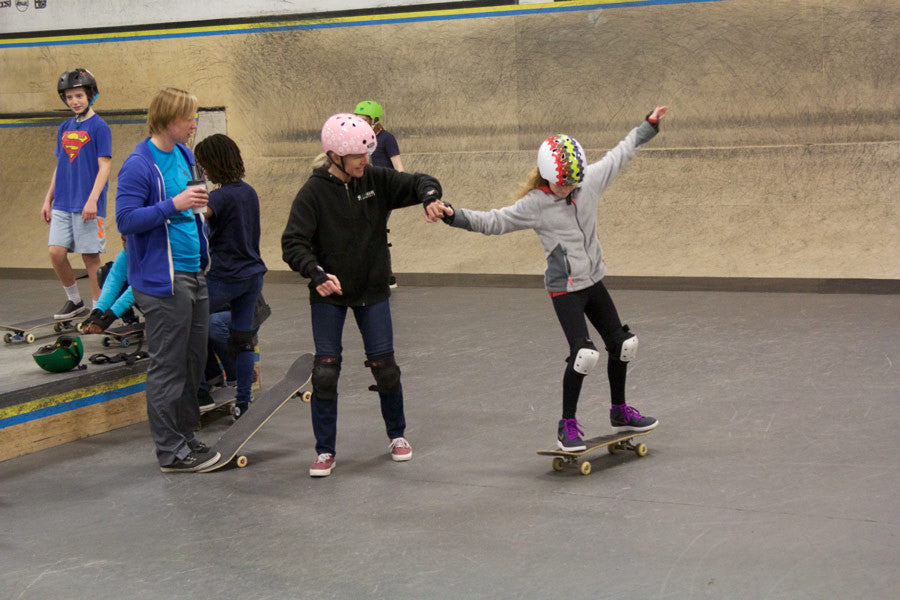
[451,121,656,292]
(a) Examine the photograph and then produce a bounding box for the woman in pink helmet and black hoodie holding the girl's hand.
[281,114,443,477]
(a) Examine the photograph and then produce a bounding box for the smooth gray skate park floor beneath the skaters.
[0,281,900,600]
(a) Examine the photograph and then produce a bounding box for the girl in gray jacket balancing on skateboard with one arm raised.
[439,106,666,451]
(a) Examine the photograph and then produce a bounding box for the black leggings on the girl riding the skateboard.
[553,281,628,419]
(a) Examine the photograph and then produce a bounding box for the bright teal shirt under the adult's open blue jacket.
[147,140,200,273]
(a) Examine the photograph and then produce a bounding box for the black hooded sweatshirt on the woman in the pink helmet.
[281,165,441,306]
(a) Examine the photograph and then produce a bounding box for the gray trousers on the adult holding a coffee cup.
[134,271,209,466]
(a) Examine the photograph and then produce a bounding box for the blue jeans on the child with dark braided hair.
[206,273,263,402]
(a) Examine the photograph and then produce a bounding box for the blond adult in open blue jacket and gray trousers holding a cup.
[116,88,219,472]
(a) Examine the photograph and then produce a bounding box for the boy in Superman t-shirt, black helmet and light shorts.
[41,69,112,319]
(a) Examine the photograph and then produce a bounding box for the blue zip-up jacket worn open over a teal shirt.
[116,138,209,297]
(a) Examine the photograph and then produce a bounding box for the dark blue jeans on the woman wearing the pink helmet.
[310,300,406,454]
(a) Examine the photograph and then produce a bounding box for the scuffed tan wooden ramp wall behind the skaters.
[0,0,900,281]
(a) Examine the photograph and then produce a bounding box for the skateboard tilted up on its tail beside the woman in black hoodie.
[200,354,313,473]
